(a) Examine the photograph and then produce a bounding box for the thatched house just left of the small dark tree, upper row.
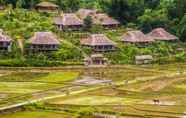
[54,13,83,30]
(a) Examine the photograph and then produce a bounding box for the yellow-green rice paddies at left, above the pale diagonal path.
[0,72,79,106]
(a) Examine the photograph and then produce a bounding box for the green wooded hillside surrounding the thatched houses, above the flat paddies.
[0,0,186,66]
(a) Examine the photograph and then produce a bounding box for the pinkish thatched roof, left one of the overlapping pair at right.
[121,31,154,43]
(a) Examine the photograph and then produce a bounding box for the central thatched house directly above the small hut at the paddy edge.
[80,34,116,52]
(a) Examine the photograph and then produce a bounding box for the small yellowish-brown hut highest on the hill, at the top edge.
[36,2,59,13]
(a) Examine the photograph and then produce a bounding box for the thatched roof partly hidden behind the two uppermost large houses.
[77,9,97,19]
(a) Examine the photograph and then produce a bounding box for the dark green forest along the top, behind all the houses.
[0,0,186,40]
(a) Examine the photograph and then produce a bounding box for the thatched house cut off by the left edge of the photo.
[0,29,11,51]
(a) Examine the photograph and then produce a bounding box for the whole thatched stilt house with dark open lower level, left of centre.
[29,32,60,51]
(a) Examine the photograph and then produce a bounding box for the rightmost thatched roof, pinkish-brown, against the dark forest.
[147,28,178,41]
